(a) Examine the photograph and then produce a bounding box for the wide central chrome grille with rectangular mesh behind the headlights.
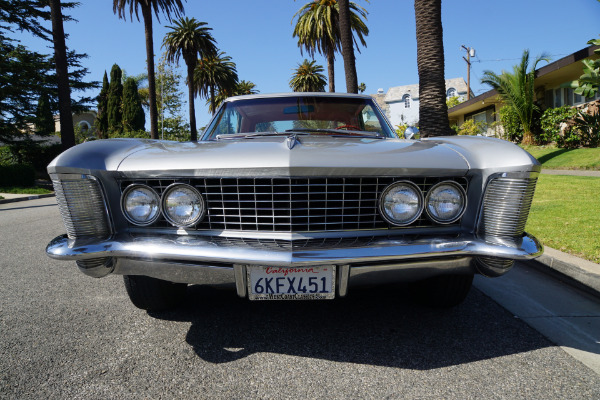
[121,177,467,232]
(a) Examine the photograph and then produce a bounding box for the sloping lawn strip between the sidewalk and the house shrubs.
[523,146,600,170]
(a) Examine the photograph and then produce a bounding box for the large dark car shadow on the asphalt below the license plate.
[151,286,552,370]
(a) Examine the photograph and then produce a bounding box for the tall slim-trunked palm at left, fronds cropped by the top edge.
[113,0,183,139]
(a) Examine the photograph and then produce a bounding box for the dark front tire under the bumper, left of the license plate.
[123,275,187,311]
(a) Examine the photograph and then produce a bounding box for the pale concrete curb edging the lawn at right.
[531,246,600,298]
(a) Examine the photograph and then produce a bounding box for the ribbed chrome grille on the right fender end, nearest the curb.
[479,178,537,239]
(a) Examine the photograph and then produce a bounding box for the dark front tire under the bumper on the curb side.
[412,274,473,308]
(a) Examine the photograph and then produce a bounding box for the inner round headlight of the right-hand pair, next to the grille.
[379,182,423,226]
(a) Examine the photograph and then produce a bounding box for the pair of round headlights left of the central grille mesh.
[121,183,206,228]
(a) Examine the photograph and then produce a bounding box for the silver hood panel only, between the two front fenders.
[118,136,468,176]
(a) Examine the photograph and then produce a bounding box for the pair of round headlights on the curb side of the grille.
[379,181,467,226]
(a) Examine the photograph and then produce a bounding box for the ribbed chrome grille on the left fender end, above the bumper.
[52,175,110,239]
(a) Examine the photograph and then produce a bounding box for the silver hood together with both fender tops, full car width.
[48,135,536,176]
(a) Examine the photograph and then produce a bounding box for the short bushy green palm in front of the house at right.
[481,50,550,144]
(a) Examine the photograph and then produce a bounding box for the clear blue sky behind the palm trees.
[14,0,600,126]
